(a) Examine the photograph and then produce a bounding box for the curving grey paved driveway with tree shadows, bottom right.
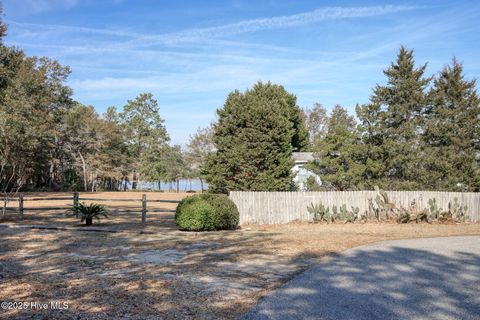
[243,236,480,320]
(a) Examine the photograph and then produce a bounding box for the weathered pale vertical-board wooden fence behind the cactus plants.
[229,191,480,224]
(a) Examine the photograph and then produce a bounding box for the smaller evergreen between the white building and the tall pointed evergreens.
[309,106,364,190]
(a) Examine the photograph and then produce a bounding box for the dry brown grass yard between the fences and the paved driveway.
[0,194,480,319]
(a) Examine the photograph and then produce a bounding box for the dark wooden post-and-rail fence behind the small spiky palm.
[6,192,180,223]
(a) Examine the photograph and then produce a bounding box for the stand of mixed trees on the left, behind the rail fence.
[0,12,209,195]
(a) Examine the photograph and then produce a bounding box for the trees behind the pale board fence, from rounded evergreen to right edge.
[203,46,480,192]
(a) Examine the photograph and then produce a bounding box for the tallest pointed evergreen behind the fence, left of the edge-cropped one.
[357,46,431,190]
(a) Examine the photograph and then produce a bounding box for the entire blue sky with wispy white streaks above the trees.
[3,0,480,144]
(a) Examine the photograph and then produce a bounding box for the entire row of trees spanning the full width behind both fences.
[0,5,480,194]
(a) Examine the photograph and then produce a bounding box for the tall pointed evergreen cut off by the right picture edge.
[424,58,480,191]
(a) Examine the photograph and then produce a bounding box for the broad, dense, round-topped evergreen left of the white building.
[204,82,308,192]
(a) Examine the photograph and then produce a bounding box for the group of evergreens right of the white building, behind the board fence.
[311,47,480,191]
